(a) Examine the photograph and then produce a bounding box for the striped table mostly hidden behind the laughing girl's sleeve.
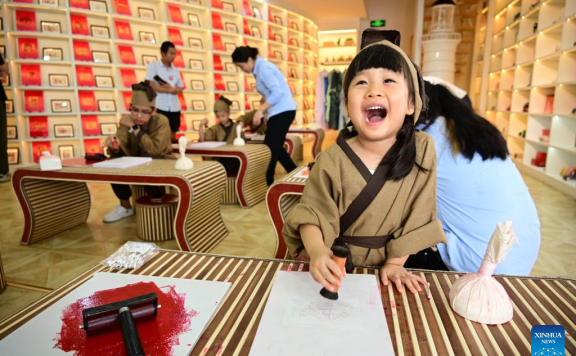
[266,167,306,258]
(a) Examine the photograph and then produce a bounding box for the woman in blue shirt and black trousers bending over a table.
[232,46,296,185]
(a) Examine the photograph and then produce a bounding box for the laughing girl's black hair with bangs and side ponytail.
[342,45,427,180]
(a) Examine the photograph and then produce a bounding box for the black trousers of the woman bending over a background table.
[264,111,296,186]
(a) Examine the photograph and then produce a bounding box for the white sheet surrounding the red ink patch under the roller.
[0,273,231,356]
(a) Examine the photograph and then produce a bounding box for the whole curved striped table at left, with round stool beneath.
[12,159,228,252]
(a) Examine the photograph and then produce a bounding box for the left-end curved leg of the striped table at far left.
[12,177,90,245]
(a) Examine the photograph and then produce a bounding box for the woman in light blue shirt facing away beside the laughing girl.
[419,82,540,275]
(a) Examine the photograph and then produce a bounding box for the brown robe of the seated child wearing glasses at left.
[108,114,176,159]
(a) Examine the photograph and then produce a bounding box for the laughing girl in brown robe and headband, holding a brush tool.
[283,32,446,293]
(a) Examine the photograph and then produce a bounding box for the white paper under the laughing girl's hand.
[245,271,394,356]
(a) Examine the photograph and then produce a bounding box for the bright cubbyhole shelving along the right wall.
[486,0,576,197]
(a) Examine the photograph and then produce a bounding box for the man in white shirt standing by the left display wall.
[146,41,184,141]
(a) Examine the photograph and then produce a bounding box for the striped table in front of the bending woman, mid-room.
[183,145,270,208]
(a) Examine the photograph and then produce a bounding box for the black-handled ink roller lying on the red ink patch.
[80,293,160,356]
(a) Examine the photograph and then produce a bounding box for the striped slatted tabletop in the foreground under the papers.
[0,250,576,356]
